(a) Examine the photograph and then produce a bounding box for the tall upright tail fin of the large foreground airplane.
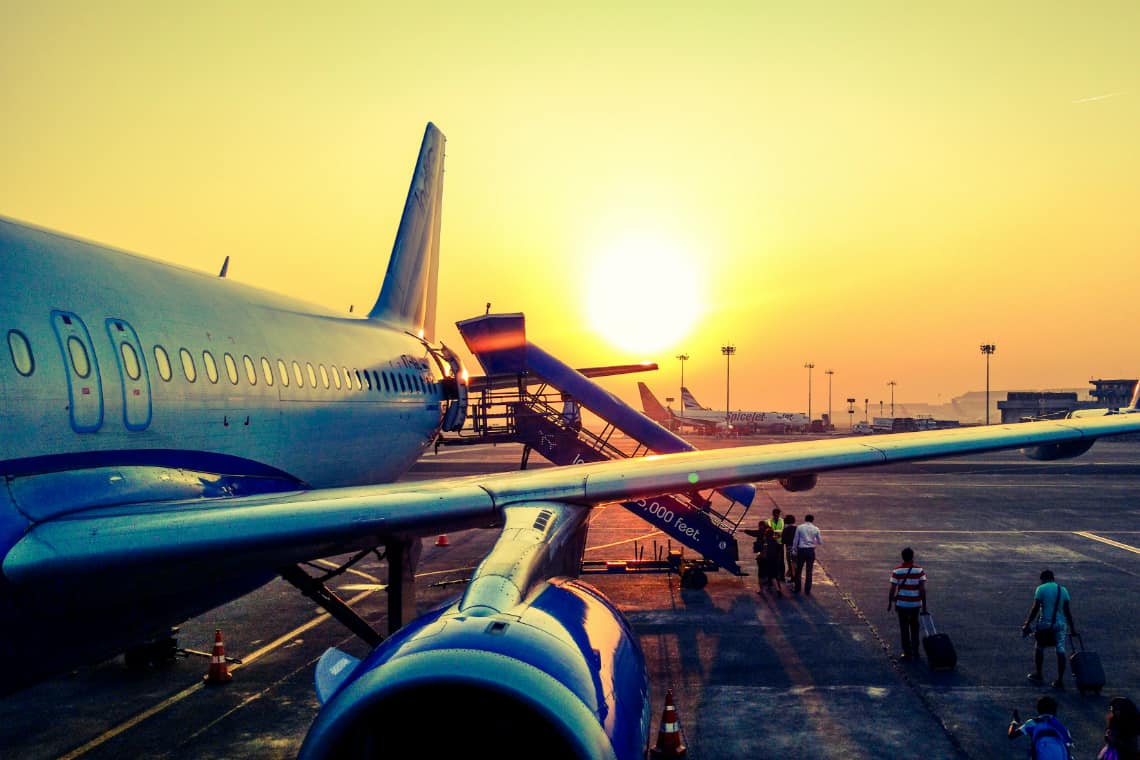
[368,122,447,341]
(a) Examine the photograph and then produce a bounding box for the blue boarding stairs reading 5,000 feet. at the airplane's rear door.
[445,313,756,574]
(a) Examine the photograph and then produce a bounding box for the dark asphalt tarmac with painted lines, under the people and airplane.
[0,439,1140,760]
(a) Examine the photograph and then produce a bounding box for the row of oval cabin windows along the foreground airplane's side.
[8,329,437,393]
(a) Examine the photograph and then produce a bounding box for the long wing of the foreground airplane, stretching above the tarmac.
[3,414,1140,594]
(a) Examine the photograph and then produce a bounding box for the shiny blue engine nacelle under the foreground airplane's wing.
[300,578,650,760]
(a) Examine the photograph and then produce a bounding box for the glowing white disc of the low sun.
[584,234,705,357]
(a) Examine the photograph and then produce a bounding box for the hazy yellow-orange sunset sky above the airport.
[0,0,1140,415]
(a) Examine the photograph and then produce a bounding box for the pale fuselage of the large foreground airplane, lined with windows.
[0,219,443,688]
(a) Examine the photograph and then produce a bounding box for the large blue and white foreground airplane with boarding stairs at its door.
[0,123,1140,760]
